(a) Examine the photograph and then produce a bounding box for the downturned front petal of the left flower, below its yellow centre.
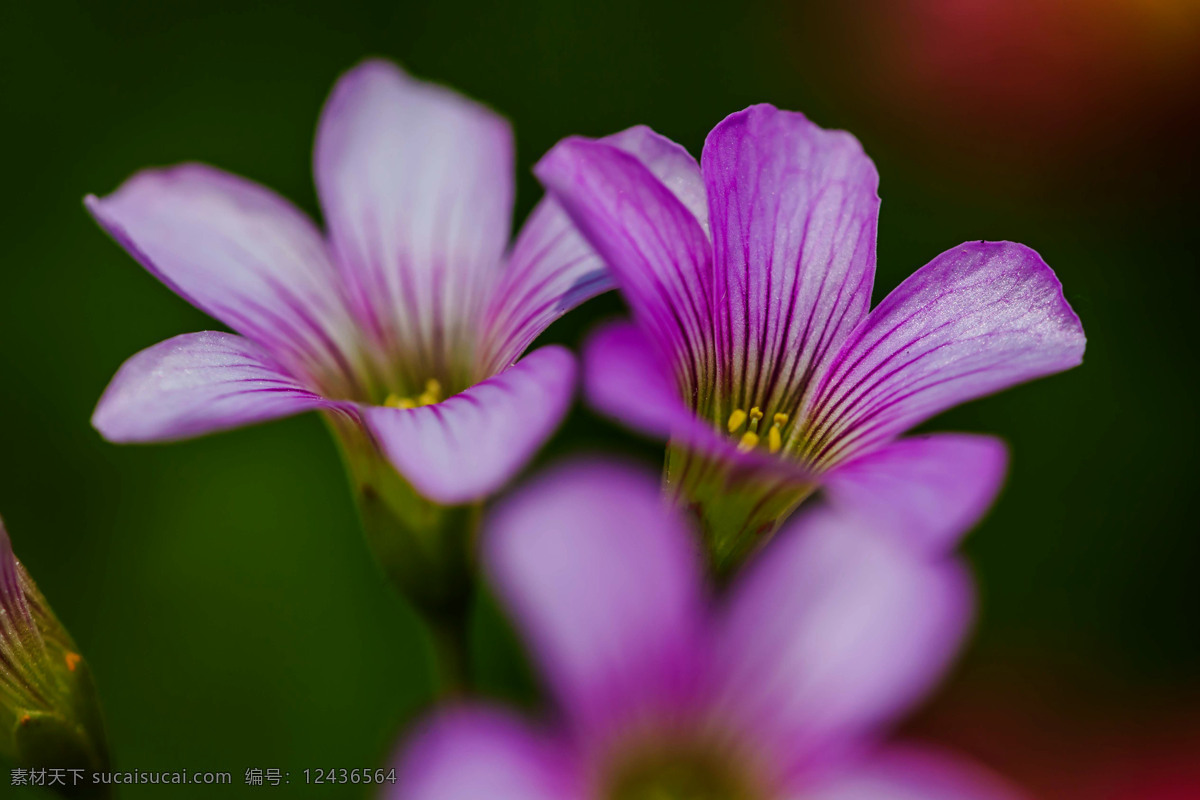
[365,345,575,505]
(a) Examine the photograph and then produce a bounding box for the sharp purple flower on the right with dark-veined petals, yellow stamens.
[535,106,1085,570]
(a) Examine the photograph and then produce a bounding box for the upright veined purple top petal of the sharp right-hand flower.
[702,104,880,414]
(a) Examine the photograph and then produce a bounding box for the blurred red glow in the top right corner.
[792,0,1200,194]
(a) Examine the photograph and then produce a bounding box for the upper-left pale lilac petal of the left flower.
[84,164,353,388]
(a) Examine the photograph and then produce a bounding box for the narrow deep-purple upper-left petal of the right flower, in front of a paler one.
[534,137,718,407]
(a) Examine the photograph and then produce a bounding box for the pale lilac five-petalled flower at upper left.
[86,61,608,504]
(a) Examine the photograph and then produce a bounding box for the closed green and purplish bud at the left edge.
[0,522,108,770]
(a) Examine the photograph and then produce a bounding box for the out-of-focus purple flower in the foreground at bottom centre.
[395,463,1027,800]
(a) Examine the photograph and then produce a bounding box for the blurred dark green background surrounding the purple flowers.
[0,0,1200,798]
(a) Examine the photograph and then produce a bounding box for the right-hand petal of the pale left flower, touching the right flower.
[479,198,612,374]
